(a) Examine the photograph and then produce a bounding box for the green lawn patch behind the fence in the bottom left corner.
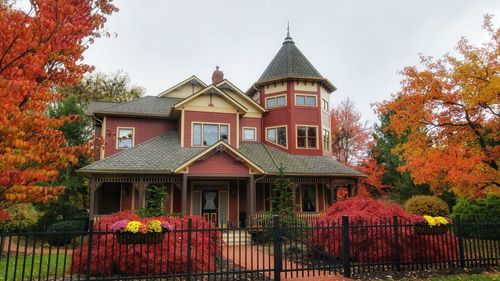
[0,254,71,281]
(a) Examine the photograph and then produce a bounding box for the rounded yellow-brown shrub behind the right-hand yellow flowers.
[404,195,450,217]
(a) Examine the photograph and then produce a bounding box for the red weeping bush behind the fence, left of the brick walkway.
[70,212,222,276]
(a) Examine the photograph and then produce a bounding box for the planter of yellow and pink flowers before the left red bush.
[111,219,172,244]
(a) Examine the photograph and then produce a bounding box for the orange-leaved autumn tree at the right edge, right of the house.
[377,16,500,197]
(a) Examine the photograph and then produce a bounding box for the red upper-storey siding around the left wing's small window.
[104,116,177,157]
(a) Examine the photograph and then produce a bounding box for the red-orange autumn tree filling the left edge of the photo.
[0,0,117,219]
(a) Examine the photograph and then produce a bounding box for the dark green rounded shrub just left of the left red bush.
[47,220,86,246]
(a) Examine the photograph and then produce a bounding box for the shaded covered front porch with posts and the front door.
[90,174,357,227]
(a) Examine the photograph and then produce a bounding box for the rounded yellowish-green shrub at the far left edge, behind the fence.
[0,203,40,232]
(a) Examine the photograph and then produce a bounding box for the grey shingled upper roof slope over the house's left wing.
[93,96,182,118]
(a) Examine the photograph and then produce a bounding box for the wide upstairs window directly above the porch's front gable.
[193,123,229,146]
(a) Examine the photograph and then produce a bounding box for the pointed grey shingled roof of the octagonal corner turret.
[249,31,336,92]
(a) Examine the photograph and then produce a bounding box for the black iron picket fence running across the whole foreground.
[0,216,500,281]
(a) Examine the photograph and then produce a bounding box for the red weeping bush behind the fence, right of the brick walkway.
[309,197,457,263]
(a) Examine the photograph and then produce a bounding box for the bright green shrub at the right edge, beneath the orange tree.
[452,194,500,239]
